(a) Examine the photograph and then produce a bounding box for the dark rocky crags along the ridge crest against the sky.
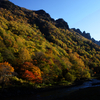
[1,0,100,46]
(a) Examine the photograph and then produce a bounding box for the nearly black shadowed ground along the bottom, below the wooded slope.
[0,78,98,100]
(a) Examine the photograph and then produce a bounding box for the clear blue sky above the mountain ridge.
[9,0,100,40]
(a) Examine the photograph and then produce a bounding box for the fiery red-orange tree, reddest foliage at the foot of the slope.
[21,62,42,83]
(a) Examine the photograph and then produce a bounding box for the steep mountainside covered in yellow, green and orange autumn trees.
[0,0,100,86]
